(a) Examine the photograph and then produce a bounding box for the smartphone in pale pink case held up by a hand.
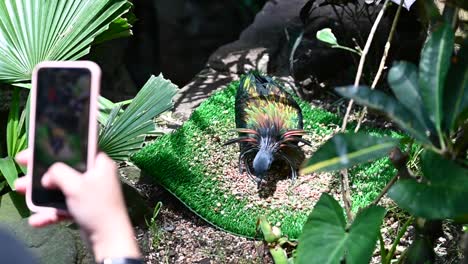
[26,61,101,212]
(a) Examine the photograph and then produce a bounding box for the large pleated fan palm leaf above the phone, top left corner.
[0,0,131,83]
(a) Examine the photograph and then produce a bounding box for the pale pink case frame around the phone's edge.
[26,61,101,213]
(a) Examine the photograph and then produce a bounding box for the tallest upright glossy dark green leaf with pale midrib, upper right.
[419,23,454,137]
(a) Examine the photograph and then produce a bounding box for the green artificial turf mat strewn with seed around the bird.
[132,82,401,238]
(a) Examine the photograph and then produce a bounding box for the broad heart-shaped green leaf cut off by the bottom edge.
[295,193,385,264]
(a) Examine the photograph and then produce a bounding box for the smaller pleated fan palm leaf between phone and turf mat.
[99,75,177,160]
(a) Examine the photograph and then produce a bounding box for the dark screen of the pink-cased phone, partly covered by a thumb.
[31,68,91,210]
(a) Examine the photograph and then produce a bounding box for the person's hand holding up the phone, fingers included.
[15,150,140,261]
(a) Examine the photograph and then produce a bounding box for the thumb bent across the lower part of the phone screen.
[41,163,83,196]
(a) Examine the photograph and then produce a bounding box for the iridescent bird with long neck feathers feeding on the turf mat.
[225,72,309,186]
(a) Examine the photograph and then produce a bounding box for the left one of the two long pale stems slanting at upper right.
[341,0,389,132]
